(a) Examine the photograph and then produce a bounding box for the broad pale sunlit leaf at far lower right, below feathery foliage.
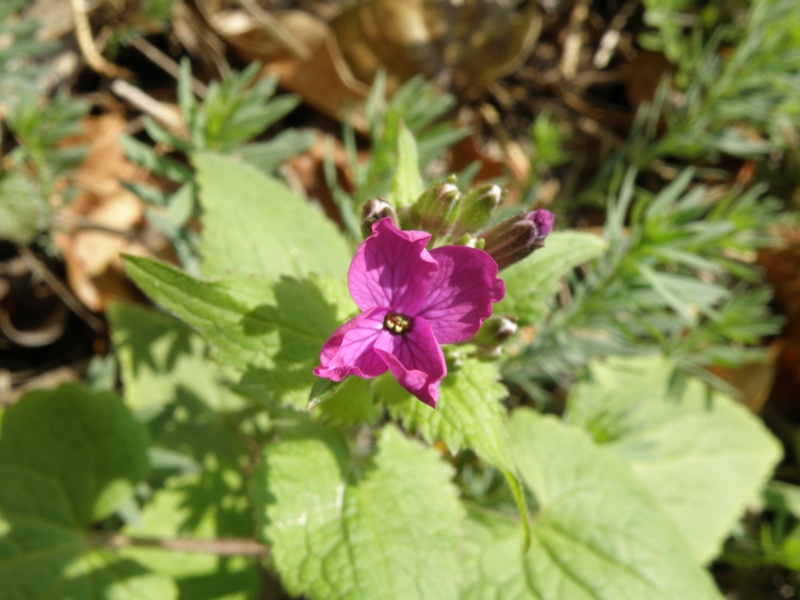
[566,357,782,562]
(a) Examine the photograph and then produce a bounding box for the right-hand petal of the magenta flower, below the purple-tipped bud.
[418,246,506,344]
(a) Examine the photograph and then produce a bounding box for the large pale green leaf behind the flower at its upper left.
[193,154,352,280]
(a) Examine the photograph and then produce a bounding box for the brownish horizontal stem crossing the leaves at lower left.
[90,532,269,557]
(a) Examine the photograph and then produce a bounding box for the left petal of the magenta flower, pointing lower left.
[314,307,391,381]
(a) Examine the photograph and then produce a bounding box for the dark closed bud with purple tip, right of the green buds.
[480,209,555,269]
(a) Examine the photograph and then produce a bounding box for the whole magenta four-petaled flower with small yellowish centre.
[314,218,505,408]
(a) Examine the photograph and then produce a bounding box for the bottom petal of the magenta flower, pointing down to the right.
[375,317,447,408]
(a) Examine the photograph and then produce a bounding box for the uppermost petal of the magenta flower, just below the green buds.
[347,218,436,315]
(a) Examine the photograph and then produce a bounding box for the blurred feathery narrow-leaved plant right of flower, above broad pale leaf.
[504,170,781,397]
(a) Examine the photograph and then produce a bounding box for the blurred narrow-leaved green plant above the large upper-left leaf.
[120,60,313,273]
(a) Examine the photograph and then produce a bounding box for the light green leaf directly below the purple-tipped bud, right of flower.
[494,231,606,325]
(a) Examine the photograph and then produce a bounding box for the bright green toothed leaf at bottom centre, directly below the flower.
[254,424,463,600]
